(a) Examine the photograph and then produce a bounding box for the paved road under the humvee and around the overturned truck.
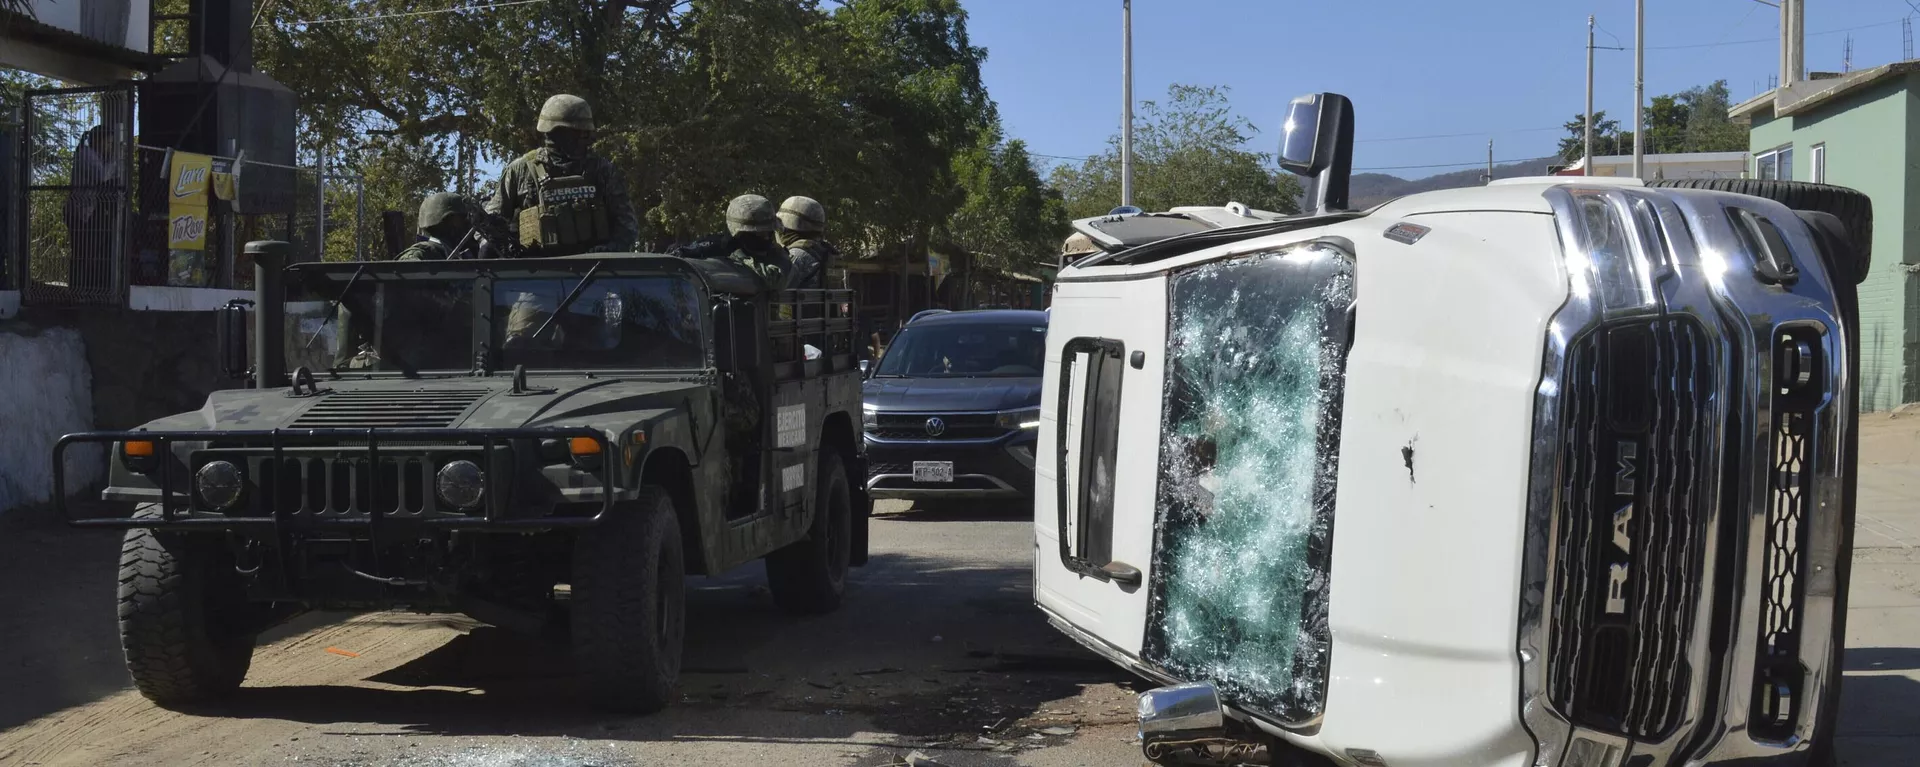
[0,417,1920,767]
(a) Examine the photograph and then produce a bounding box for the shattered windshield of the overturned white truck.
[1144,244,1354,721]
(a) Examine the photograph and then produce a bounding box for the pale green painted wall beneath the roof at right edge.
[1749,75,1920,409]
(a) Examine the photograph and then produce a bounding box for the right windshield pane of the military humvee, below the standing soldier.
[492,275,707,369]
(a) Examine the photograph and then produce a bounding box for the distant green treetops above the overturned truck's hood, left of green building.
[1559,81,1747,163]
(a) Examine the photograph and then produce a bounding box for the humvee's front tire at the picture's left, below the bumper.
[119,506,253,705]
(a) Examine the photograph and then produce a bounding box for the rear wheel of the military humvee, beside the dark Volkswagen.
[766,450,852,615]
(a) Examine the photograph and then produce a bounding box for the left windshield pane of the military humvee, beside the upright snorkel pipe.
[286,275,474,375]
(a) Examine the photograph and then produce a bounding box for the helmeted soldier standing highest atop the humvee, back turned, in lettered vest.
[486,94,639,256]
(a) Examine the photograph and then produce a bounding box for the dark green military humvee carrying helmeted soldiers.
[54,242,870,711]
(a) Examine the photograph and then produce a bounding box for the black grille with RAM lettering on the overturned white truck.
[1548,319,1716,740]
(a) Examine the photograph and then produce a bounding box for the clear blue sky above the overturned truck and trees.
[966,0,1920,177]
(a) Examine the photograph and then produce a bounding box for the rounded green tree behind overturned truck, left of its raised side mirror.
[1052,85,1300,217]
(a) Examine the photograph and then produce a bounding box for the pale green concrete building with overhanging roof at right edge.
[1732,62,1920,409]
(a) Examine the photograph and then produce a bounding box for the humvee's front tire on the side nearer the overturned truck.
[570,486,687,713]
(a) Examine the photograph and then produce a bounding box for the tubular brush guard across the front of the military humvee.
[54,427,620,536]
